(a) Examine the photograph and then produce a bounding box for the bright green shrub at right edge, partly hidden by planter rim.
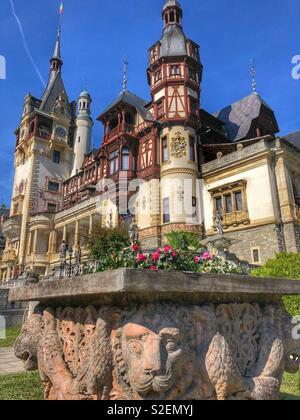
[252,253,300,316]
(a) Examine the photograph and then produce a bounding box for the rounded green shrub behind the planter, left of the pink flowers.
[88,226,130,264]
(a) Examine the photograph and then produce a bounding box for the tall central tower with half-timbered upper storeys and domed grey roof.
[148,0,202,240]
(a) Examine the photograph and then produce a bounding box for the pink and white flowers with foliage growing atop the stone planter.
[93,245,243,274]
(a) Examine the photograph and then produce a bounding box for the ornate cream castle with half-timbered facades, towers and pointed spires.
[0,0,300,282]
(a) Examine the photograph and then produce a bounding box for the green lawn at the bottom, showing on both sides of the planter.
[0,373,300,401]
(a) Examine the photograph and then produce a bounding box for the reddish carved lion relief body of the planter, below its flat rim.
[15,303,300,400]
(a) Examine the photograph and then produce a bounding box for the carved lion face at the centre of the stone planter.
[115,304,196,399]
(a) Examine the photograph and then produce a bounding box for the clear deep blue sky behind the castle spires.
[0,0,300,204]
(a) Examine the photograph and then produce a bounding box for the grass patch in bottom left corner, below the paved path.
[0,372,44,401]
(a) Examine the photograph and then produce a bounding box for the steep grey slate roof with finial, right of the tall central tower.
[214,93,273,141]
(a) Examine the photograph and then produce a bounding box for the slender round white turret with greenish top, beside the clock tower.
[72,91,94,176]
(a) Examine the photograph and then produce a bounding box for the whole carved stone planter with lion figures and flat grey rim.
[10,270,300,400]
